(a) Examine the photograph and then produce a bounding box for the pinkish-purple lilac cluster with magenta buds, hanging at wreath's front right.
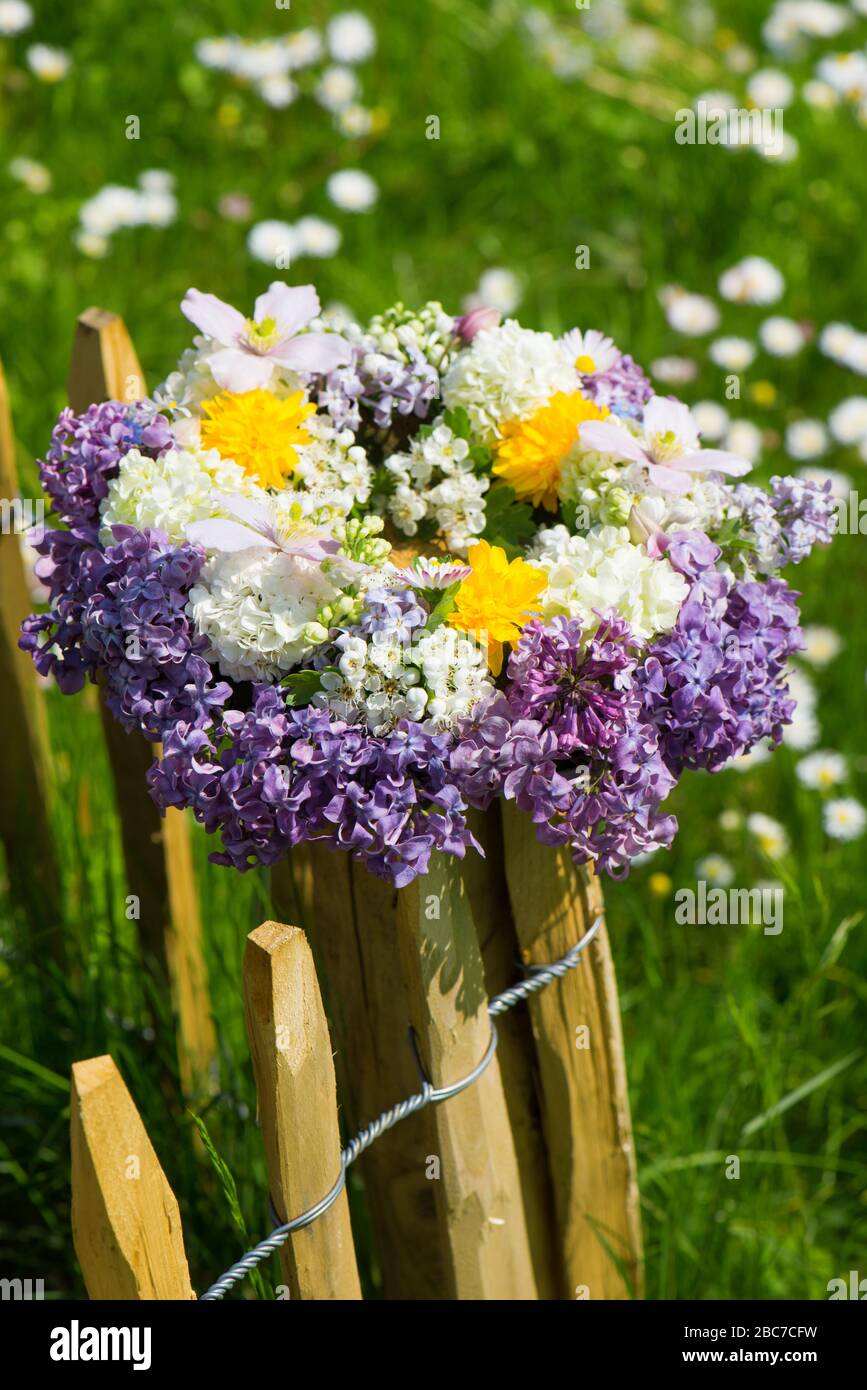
[450,614,677,877]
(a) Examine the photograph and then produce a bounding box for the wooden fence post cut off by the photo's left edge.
[0,364,64,934]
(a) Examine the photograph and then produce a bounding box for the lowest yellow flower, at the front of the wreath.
[449,541,547,676]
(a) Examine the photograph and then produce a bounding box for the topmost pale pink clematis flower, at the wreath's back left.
[181,279,352,392]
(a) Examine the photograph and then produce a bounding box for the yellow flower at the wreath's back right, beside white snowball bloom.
[493,391,609,512]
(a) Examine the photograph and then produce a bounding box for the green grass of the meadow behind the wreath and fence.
[0,0,867,1298]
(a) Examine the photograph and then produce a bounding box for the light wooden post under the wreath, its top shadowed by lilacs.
[397,855,538,1300]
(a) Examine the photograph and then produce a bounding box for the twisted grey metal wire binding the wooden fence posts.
[199,915,603,1302]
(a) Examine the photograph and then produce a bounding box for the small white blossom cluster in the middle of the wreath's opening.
[385,421,490,556]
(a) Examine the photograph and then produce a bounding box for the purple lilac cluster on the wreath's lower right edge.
[636,532,802,776]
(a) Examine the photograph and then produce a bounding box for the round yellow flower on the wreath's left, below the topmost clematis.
[201,389,315,488]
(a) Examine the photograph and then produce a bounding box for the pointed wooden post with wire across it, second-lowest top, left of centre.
[245,922,361,1300]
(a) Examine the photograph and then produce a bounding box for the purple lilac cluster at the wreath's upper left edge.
[39,400,174,527]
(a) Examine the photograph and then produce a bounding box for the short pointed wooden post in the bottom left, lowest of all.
[71,1056,196,1300]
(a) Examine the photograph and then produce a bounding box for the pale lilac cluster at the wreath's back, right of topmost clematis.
[313,346,439,432]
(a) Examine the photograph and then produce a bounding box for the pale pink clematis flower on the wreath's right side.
[578,396,752,492]
